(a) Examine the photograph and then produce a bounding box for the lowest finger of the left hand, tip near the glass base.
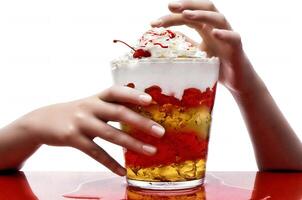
[72,135,126,176]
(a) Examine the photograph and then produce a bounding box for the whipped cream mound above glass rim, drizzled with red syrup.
[112,28,218,66]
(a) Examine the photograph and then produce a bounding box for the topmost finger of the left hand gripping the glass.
[99,86,152,105]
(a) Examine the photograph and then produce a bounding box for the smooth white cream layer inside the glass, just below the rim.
[112,60,220,100]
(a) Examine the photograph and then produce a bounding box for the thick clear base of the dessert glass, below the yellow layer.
[127,178,204,190]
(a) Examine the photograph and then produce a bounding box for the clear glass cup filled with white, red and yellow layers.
[112,58,220,190]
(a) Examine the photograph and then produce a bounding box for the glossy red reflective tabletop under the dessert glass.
[0,172,302,200]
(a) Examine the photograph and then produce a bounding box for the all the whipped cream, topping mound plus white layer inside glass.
[111,28,220,99]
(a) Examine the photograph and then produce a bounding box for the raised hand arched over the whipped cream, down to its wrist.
[151,0,255,93]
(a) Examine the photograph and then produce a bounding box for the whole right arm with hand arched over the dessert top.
[151,0,302,171]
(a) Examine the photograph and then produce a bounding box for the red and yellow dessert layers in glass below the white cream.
[122,83,216,181]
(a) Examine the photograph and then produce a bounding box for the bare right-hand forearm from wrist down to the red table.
[232,66,302,170]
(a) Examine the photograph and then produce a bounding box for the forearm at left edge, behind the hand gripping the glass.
[0,123,40,170]
